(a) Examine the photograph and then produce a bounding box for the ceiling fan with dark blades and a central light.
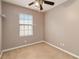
[29,0,55,10]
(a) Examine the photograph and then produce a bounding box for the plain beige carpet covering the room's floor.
[2,43,76,59]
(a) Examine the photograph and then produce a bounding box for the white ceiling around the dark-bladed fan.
[3,0,67,12]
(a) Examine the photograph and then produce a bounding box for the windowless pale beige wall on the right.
[45,0,79,55]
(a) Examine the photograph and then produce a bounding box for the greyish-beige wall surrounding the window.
[2,2,44,49]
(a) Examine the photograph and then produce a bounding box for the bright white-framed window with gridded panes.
[19,14,33,36]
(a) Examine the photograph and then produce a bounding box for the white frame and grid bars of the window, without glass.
[19,13,34,37]
